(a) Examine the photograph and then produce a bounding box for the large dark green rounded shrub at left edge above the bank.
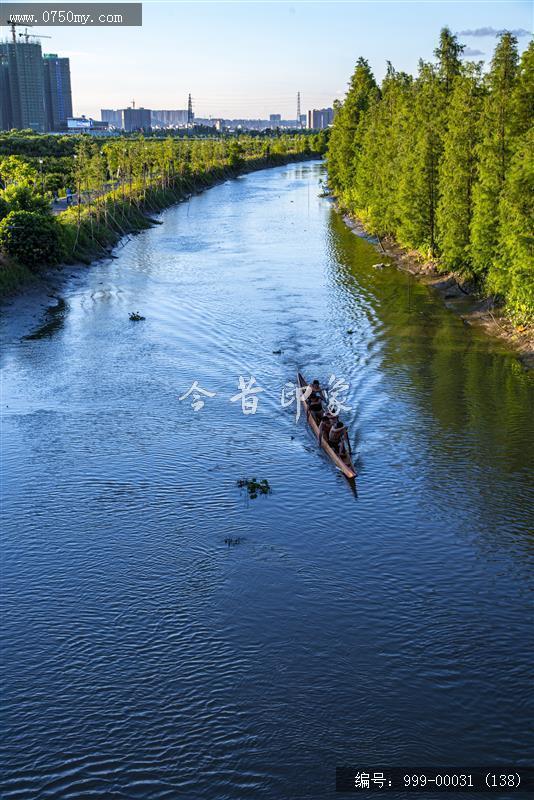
[0,211,61,272]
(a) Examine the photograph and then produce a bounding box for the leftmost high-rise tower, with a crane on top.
[0,42,47,133]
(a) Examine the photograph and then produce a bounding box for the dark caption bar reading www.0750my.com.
[0,0,143,26]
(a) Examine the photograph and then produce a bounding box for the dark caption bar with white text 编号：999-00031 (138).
[336,767,534,797]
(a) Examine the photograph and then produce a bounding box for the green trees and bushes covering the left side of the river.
[0,131,326,294]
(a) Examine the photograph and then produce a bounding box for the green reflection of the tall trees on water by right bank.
[330,212,534,446]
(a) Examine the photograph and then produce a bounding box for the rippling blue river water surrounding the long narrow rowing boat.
[1,162,534,800]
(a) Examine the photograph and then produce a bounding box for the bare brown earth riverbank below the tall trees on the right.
[344,208,534,370]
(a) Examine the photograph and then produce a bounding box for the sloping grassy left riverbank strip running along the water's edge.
[0,152,321,301]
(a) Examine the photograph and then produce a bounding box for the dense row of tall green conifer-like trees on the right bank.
[327,28,534,323]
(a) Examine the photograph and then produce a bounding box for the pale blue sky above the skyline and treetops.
[3,0,533,118]
